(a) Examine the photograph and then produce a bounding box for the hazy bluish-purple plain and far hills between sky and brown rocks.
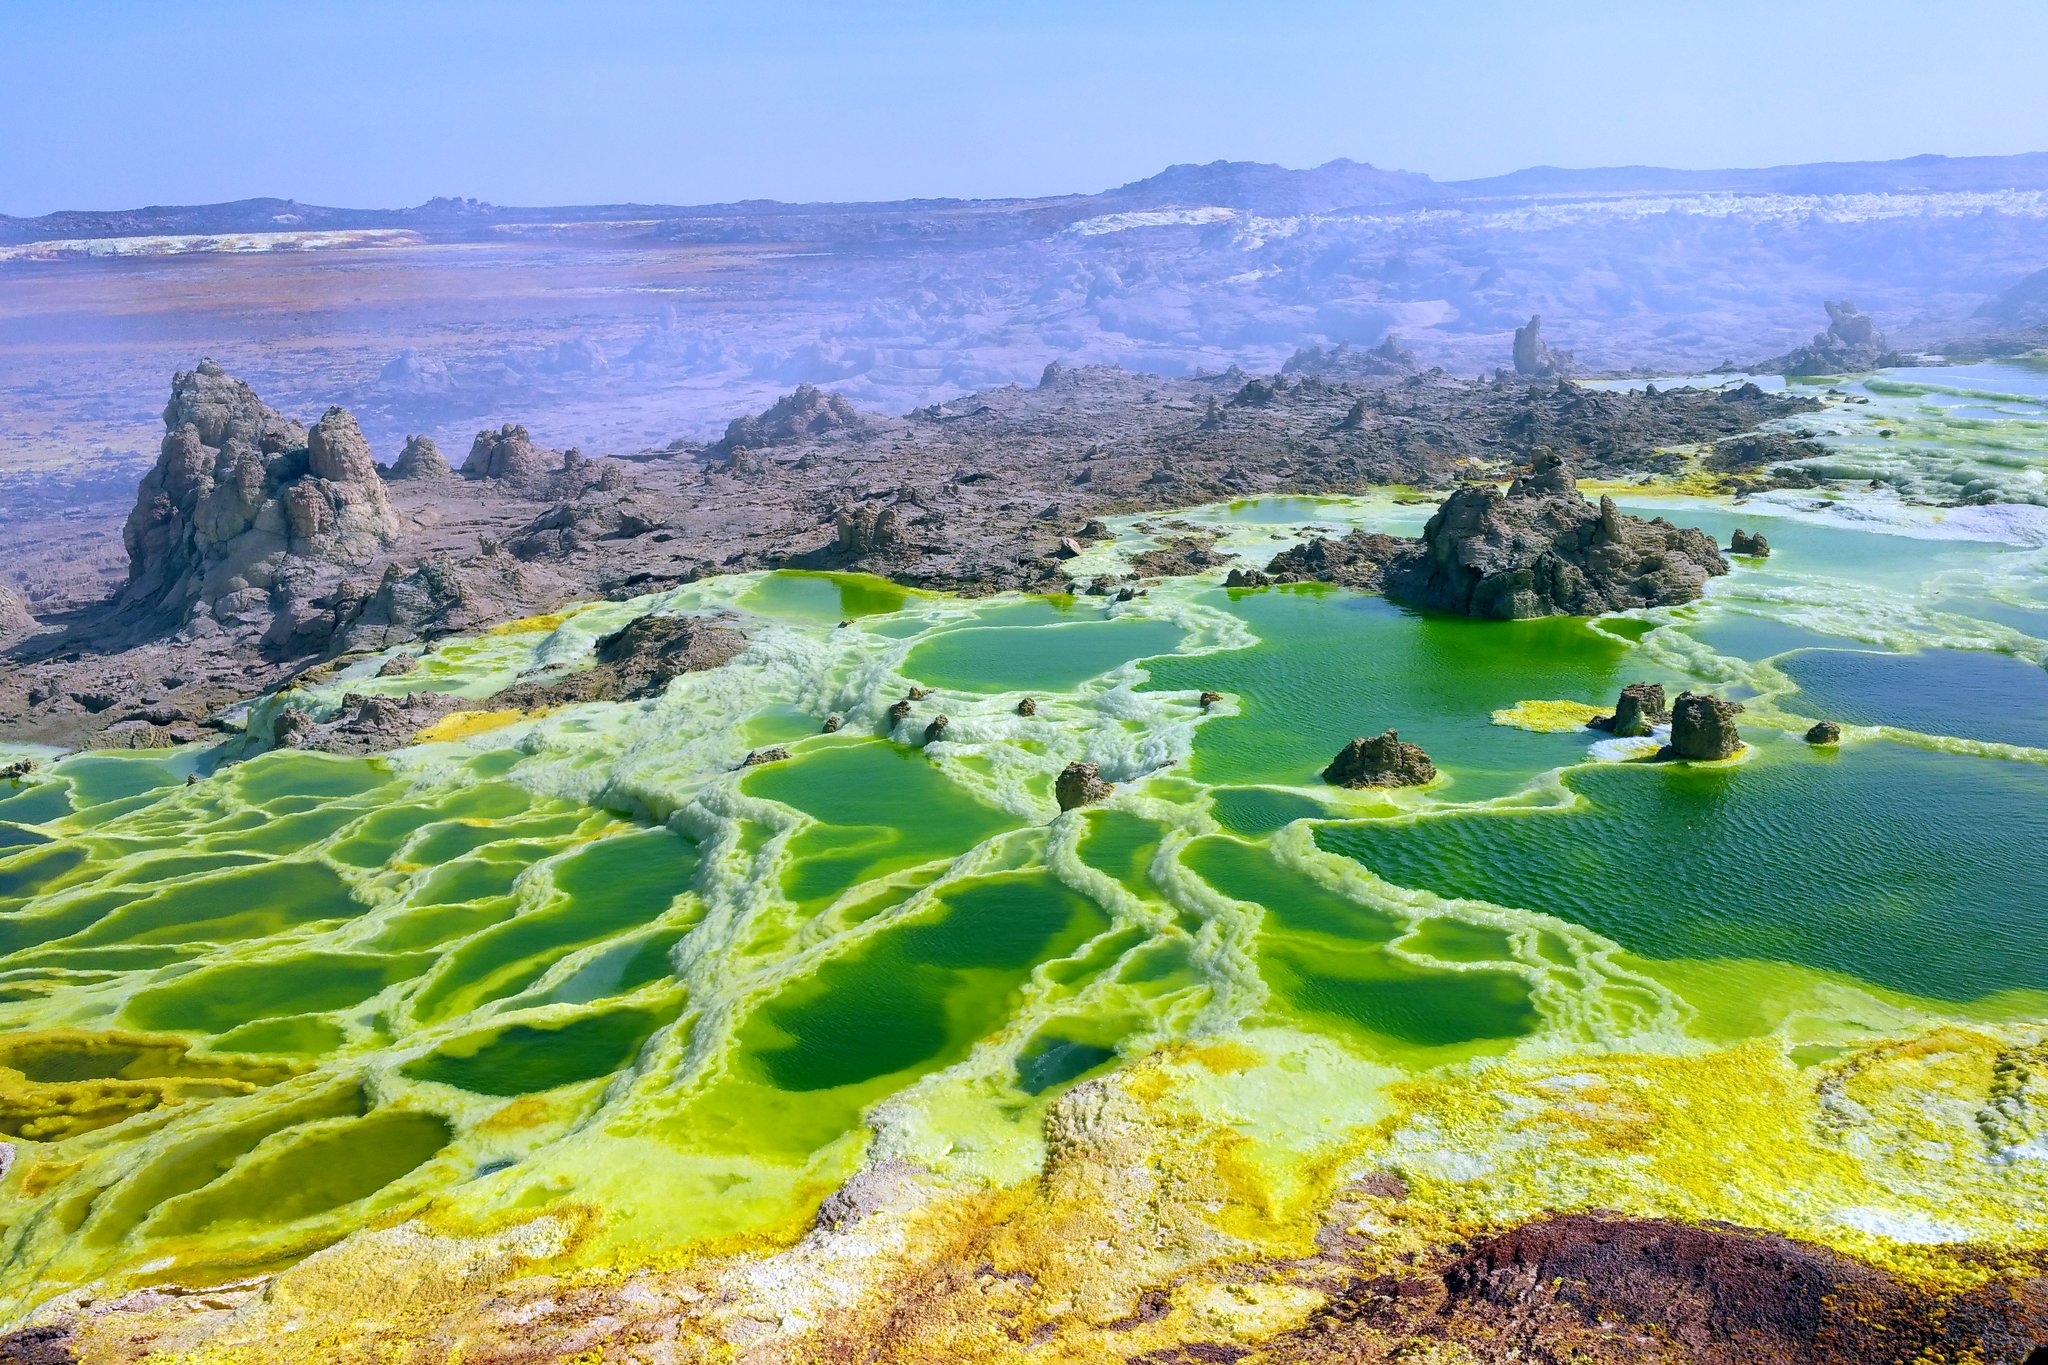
[0,156,2048,507]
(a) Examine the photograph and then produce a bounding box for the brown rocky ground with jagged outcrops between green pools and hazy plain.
[0,356,1815,745]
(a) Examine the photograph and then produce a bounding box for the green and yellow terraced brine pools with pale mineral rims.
[0,480,2048,1308]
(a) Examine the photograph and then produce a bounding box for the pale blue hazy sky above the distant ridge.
[0,0,2048,215]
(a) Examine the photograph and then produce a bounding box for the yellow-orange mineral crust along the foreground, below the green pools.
[39,1027,2048,1365]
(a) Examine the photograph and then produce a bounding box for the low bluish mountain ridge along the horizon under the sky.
[16,151,2048,244]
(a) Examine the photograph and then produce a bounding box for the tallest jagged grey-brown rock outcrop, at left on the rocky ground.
[121,360,397,645]
